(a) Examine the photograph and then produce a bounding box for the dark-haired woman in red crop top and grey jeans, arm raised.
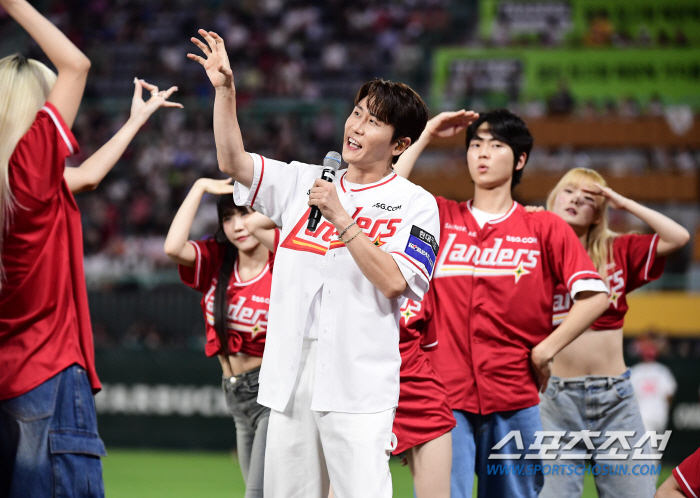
[165,178,273,498]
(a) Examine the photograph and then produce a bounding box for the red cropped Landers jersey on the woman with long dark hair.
[179,234,279,357]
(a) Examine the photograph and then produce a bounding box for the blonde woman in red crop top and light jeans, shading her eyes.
[540,168,690,498]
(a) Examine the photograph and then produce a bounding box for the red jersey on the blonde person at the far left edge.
[0,102,100,399]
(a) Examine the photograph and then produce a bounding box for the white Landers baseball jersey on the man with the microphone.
[234,154,439,413]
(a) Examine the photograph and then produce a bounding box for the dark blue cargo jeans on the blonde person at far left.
[0,365,107,498]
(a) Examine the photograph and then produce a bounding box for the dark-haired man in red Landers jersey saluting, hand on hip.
[395,110,607,498]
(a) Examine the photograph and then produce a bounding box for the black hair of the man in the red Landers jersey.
[466,109,534,190]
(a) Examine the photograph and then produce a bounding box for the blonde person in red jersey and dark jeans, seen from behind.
[0,0,105,497]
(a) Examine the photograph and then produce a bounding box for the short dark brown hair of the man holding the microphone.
[355,79,428,163]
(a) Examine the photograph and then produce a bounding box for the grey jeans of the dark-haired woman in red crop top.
[222,367,270,498]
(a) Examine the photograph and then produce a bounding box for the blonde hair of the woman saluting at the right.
[547,168,618,280]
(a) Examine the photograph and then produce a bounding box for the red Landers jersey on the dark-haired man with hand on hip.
[428,197,600,414]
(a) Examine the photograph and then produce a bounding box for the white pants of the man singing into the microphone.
[264,340,395,498]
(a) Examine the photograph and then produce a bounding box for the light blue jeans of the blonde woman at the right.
[540,370,660,498]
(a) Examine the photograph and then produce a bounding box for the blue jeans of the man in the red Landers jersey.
[450,405,544,498]
